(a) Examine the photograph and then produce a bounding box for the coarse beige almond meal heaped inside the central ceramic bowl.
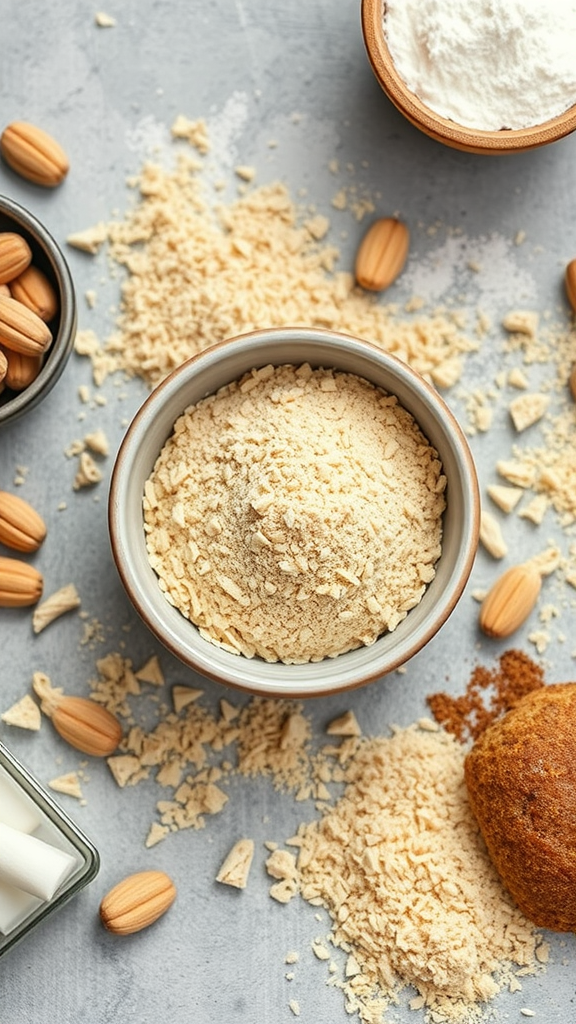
[143,364,446,664]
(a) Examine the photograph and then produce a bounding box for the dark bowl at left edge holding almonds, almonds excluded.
[0,196,76,427]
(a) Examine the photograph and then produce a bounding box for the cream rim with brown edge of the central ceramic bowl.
[108,328,480,698]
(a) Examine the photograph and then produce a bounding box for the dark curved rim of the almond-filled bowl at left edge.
[0,195,77,427]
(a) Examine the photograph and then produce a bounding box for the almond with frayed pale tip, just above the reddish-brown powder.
[480,563,542,638]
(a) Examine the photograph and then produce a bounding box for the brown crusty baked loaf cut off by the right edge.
[464,683,576,932]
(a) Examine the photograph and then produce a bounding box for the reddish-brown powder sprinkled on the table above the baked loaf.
[426,649,544,742]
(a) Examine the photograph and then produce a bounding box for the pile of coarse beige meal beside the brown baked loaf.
[275,725,541,1024]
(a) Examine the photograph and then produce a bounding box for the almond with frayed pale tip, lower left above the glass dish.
[51,696,122,758]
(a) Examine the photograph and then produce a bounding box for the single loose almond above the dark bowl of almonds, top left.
[0,121,70,188]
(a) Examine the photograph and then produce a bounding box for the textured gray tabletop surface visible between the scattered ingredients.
[0,0,576,1024]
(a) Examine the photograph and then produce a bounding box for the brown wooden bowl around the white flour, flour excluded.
[362,0,576,154]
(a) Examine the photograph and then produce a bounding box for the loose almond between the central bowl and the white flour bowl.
[356,217,410,292]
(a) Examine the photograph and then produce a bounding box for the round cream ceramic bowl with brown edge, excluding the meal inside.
[109,329,480,697]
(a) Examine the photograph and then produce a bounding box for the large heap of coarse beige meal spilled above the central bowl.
[72,149,478,386]
